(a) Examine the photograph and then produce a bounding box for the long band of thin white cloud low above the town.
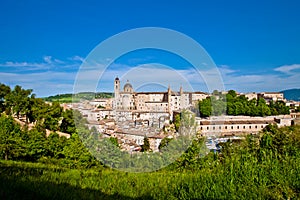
[0,56,300,96]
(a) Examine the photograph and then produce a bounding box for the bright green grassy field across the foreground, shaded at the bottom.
[0,155,300,199]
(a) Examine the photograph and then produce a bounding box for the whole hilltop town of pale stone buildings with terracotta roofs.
[65,77,299,151]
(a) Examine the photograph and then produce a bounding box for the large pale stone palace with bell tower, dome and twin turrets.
[112,77,209,119]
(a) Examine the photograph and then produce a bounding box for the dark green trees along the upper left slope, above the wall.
[0,84,76,134]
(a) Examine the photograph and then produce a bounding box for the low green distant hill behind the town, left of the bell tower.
[43,92,113,103]
